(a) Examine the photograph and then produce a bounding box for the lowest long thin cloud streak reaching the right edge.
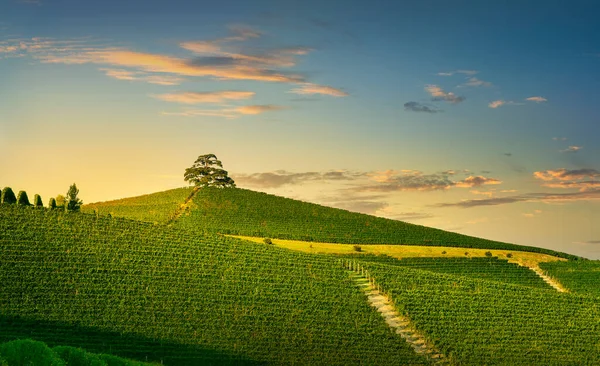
[432,189,600,208]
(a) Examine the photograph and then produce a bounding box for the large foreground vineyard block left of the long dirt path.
[0,206,422,365]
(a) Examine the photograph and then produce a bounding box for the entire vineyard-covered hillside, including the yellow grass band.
[0,188,600,365]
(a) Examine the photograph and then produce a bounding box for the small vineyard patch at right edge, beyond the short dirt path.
[540,261,600,298]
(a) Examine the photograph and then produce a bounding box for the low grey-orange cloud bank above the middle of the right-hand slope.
[352,170,502,192]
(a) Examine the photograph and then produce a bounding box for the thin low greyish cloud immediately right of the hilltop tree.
[232,170,364,189]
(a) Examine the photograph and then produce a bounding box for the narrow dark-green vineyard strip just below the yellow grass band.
[346,255,553,291]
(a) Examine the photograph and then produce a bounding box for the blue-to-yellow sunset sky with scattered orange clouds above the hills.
[0,0,600,259]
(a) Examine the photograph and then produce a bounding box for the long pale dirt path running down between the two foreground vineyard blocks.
[345,263,447,364]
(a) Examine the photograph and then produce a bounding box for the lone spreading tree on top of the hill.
[183,154,235,188]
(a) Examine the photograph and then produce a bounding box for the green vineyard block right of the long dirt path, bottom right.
[361,262,600,366]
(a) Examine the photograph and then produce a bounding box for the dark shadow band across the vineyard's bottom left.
[0,315,265,365]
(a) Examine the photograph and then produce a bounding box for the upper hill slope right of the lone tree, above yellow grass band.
[176,188,577,259]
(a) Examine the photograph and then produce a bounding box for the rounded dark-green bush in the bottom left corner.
[0,339,66,366]
